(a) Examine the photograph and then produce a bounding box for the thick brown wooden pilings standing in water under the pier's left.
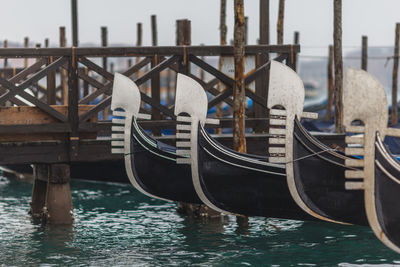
[31,164,74,224]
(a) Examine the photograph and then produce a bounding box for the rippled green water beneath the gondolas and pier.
[0,177,400,266]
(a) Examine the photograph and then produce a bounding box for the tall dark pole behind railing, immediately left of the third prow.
[253,0,269,133]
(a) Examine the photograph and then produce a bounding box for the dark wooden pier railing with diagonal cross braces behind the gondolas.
[0,45,300,139]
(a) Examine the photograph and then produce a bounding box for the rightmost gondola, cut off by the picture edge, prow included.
[343,69,400,253]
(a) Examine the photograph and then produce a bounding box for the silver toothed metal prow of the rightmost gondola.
[343,68,400,253]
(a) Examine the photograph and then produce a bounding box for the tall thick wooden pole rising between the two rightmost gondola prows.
[333,0,344,133]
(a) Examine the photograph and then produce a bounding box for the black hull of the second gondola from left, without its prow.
[197,126,315,220]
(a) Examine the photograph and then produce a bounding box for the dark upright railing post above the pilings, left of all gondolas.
[68,47,79,161]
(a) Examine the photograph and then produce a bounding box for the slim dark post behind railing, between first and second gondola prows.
[151,15,162,135]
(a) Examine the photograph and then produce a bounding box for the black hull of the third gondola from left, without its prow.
[293,119,368,225]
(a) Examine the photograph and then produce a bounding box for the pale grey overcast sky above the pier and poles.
[0,0,400,55]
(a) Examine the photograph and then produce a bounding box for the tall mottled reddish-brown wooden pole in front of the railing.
[233,0,246,153]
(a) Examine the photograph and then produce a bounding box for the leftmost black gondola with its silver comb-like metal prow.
[111,73,201,204]
